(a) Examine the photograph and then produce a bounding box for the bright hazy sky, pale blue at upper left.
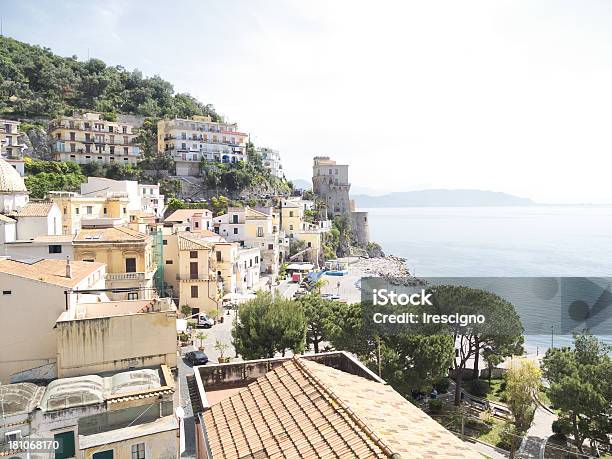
[0,0,612,203]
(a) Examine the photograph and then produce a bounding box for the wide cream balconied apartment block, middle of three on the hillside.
[48,113,140,165]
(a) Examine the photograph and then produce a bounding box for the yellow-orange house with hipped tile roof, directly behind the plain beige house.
[73,227,158,300]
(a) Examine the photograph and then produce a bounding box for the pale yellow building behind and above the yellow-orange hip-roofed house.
[49,191,131,235]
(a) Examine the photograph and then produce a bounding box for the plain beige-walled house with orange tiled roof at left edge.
[0,258,106,384]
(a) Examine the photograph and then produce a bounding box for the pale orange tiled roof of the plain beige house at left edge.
[0,258,105,287]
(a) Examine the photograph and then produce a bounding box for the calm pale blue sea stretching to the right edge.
[360,205,612,354]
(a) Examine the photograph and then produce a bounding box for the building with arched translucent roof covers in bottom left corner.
[0,365,180,459]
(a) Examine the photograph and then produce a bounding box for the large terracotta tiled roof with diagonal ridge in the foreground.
[202,358,480,459]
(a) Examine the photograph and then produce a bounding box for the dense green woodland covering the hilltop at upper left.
[0,37,220,121]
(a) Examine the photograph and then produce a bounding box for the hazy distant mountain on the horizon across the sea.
[352,190,535,207]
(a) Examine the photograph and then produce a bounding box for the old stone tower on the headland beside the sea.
[312,156,370,244]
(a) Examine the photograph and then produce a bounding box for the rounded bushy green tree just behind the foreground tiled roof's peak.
[232,292,306,360]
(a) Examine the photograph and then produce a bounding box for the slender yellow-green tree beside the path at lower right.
[506,359,541,458]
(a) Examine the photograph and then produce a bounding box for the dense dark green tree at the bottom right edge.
[543,331,612,452]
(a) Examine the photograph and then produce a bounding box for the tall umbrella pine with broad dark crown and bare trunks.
[431,285,523,406]
